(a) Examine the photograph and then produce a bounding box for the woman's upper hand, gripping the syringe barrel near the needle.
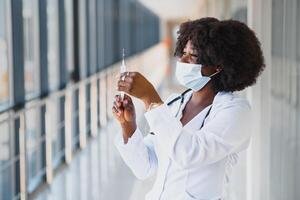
[117,72,162,108]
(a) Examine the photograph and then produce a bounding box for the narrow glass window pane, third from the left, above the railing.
[47,0,59,90]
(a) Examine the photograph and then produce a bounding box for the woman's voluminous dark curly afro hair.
[174,17,265,92]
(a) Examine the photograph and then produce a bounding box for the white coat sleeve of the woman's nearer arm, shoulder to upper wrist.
[145,100,252,168]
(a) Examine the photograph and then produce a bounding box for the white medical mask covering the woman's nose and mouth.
[176,61,219,92]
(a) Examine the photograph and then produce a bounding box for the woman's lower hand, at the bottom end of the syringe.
[112,94,136,143]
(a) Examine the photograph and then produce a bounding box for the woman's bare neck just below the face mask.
[191,84,216,106]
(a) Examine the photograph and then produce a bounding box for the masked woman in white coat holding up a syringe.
[112,18,264,200]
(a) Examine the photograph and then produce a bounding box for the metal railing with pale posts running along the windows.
[0,66,119,199]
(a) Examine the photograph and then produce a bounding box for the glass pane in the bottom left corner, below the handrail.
[0,121,17,199]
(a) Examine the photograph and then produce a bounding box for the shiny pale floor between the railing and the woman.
[33,81,182,200]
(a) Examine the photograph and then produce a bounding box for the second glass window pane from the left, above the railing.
[23,0,39,99]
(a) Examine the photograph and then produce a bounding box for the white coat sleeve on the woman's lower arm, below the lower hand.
[115,128,157,180]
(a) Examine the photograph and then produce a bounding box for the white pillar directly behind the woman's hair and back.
[247,0,272,200]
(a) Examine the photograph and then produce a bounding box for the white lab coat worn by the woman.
[115,91,252,200]
